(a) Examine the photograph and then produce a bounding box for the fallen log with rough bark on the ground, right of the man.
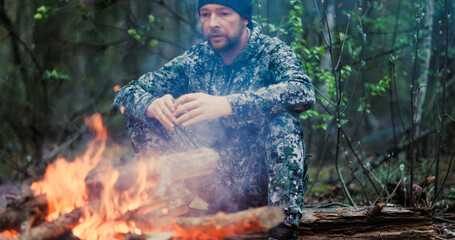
[299,207,435,240]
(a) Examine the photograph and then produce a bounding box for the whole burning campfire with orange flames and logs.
[0,114,284,240]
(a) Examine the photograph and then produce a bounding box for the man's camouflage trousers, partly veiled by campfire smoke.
[128,113,308,225]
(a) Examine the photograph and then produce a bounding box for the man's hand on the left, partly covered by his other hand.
[145,94,176,131]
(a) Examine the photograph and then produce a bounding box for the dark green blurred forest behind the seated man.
[0,0,455,222]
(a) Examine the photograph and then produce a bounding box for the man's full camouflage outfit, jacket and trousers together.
[114,23,315,224]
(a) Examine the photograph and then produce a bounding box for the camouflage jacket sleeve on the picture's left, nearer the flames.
[113,52,190,122]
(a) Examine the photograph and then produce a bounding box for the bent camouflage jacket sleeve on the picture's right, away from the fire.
[227,42,315,121]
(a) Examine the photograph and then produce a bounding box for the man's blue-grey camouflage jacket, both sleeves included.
[114,23,315,133]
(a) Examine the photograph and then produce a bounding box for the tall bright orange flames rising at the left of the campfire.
[31,114,160,240]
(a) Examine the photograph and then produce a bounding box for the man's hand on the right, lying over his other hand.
[174,93,232,127]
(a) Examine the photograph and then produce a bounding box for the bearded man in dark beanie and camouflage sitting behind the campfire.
[114,0,315,236]
